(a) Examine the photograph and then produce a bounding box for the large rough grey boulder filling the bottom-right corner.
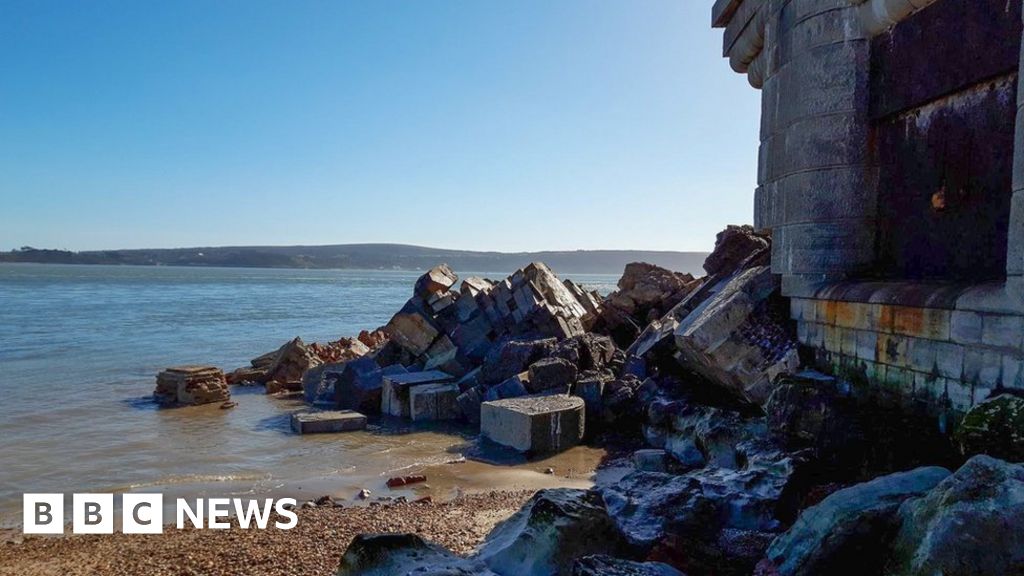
[886,456,1024,576]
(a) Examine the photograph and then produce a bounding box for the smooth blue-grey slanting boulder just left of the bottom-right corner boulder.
[767,467,949,576]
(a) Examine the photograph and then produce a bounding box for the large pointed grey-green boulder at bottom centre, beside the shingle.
[474,488,625,576]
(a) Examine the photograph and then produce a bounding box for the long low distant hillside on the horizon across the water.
[0,244,708,276]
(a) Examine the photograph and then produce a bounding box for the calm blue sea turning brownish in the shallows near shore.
[0,264,616,525]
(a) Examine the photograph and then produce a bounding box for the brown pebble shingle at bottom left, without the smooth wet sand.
[0,491,532,576]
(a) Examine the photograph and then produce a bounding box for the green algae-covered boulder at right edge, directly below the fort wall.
[956,394,1024,462]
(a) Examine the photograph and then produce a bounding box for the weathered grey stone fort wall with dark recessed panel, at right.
[713,0,1024,414]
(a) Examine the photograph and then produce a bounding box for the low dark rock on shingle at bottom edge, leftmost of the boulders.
[338,534,496,576]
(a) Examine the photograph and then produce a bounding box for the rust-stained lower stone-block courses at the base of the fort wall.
[791,298,1024,413]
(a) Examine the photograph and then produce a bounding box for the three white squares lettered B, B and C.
[22,494,164,534]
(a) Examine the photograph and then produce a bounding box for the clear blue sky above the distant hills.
[0,0,760,251]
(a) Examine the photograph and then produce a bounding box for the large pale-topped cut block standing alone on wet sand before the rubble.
[480,395,585,453]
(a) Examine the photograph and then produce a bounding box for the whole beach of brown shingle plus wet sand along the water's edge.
[0,446,628,576]
